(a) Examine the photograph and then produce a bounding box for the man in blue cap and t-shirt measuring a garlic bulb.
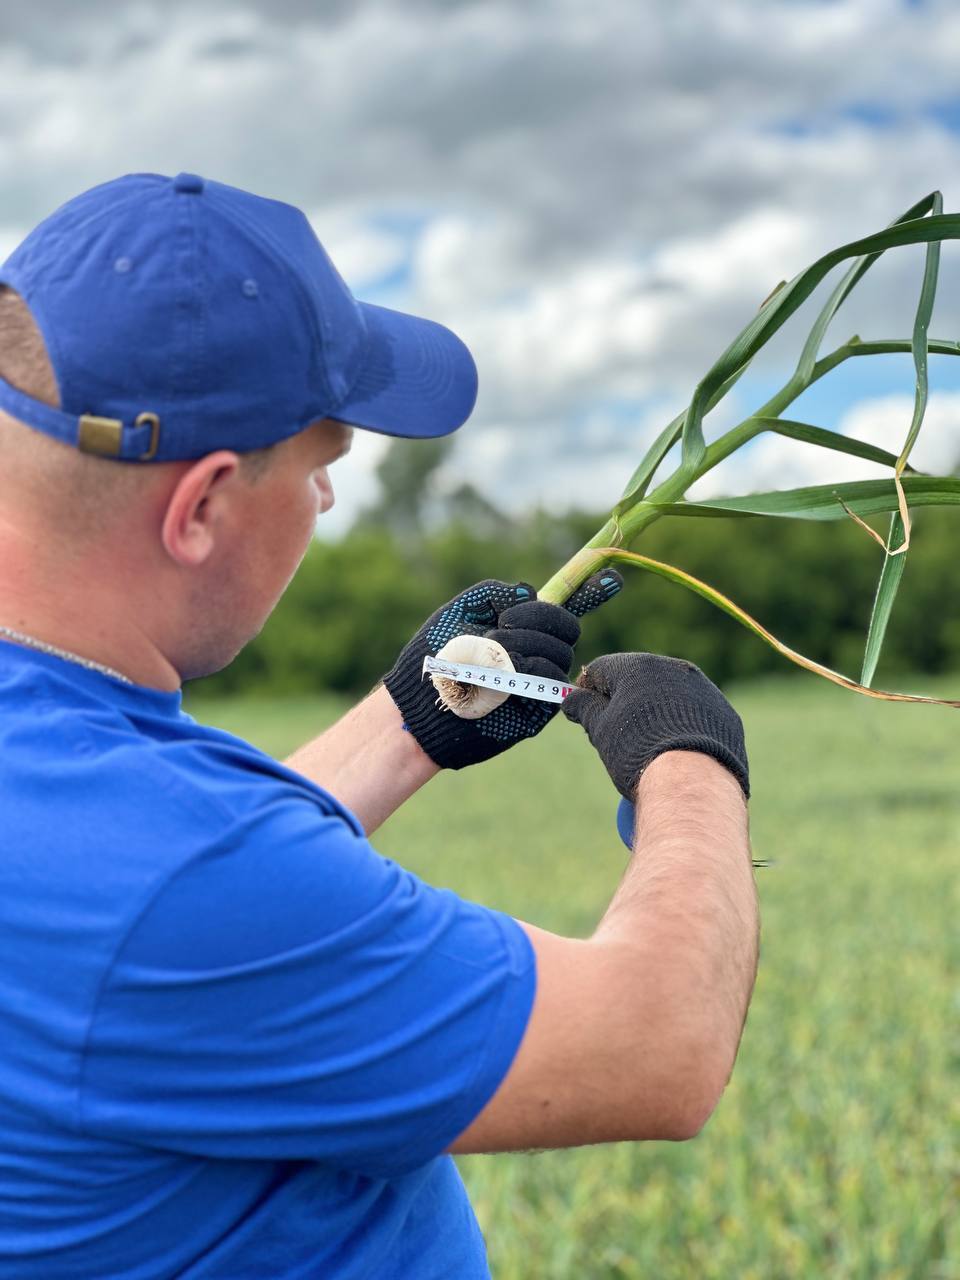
[0,174,758,1280]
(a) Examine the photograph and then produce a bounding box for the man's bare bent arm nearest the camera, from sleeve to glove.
[451,751,759,1153]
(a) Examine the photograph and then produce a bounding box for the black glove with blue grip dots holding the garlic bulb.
[384,570,623,769]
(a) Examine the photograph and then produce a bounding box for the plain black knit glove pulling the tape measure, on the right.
[563,653,750,801]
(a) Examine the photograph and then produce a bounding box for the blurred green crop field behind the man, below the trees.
[189,677,960,1280]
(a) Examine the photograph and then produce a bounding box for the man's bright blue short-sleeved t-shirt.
[0,641,535,1280]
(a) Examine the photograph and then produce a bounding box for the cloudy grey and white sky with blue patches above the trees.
[0,0,960,532]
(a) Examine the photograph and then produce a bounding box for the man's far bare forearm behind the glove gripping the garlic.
[284,686,439,835]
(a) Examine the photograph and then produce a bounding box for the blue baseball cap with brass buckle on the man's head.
[0,173,476,462]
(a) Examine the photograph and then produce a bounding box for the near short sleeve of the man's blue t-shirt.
[79,788,535,1178]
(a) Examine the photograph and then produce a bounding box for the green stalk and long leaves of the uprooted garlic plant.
[538,192,960,707]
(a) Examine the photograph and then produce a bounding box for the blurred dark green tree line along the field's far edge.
[191,437,960,695]
